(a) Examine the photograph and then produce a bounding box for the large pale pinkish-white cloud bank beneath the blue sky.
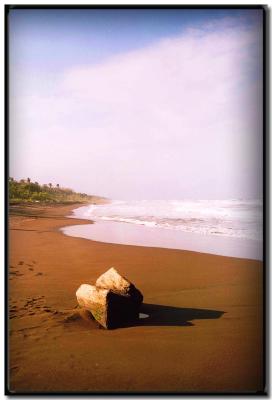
[9,20,262,198]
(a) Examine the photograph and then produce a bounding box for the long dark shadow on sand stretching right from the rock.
[130,303,224,326]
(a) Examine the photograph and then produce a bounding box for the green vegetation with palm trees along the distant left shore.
[9,178,101,204]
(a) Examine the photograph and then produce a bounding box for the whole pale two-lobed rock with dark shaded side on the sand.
[76,268,143,329]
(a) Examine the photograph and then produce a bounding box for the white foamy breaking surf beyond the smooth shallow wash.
[75,199,263,242]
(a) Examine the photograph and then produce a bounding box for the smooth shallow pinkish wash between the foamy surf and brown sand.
[60,206,263,261]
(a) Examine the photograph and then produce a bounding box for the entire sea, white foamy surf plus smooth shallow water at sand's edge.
[62,199,263,260]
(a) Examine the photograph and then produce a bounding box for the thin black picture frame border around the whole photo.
[4,4,270,397]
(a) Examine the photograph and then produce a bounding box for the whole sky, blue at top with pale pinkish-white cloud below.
[8,9,263,200]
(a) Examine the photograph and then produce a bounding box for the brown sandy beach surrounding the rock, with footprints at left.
[8,205,263,393]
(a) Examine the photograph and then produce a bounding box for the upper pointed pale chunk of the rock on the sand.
[95,268,143,305]
